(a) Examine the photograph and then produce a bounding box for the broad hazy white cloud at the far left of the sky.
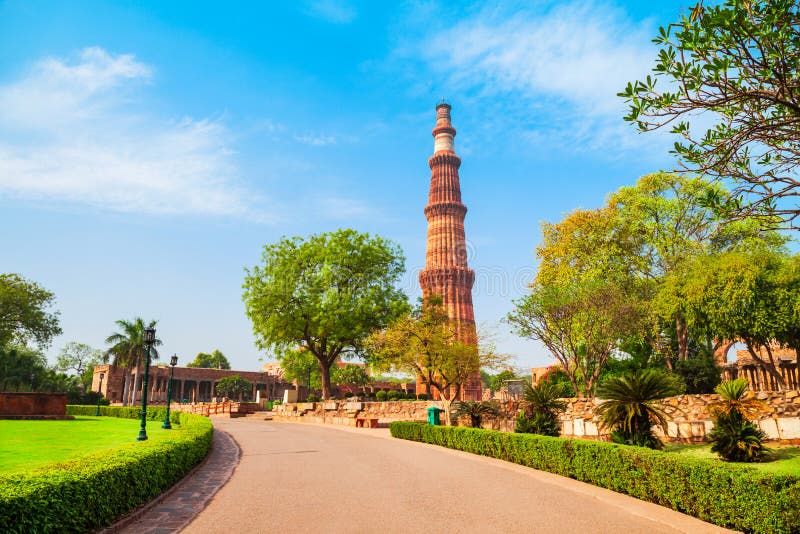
[0,48,264,217]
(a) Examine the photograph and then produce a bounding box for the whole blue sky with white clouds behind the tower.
[0,0,686,370]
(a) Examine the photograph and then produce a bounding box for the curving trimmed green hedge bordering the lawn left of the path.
[0,406,214,533]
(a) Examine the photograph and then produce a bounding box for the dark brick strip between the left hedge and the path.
[99,428,242,534]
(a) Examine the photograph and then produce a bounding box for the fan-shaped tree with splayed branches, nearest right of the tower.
[508,280,639,397]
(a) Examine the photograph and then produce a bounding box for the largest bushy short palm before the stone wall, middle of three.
[596,369,681,449]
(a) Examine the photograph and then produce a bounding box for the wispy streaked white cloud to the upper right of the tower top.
[406,1,668,156]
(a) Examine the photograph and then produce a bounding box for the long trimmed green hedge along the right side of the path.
[390,422,800,533]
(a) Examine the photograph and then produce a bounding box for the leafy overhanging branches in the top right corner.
[619,0,800,229]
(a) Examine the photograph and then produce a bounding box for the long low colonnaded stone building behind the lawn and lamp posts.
[92,365,292,404]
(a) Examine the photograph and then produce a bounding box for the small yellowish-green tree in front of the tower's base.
[368,297,508,425]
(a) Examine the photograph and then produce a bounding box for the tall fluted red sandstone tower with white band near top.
[417,100,481,400]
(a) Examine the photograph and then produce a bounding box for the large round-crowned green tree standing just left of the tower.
[243,230,408,399]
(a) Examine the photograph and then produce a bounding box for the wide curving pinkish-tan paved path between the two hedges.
[183,419,725,534]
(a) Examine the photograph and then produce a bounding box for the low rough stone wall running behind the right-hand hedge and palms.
[273,390,800,444]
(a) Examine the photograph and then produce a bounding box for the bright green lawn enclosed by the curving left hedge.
[0,416,179,473]
